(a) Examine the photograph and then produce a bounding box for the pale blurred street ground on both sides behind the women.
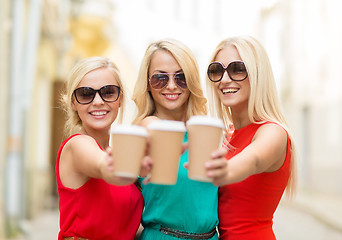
[16,193,342,240]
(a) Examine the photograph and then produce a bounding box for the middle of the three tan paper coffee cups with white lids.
[147,120,186,185]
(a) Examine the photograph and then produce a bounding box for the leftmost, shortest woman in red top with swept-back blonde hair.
[56,57,143,240]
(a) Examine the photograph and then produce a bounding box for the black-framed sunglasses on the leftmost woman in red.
[74,85,120,104]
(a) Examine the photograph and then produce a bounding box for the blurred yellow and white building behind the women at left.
[0,0,129,239]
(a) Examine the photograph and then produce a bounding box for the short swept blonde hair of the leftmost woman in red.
[61,57,126,135]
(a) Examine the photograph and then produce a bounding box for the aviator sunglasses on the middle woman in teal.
[150,73,188,89]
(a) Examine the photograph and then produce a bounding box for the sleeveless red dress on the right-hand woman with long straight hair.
[218,123,291,240]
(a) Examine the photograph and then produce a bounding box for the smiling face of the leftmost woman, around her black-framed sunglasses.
[72,68,120,133]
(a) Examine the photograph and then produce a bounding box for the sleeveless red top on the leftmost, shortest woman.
[56,135,144,240]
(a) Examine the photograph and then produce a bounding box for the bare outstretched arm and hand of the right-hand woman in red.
[206,124,287,186]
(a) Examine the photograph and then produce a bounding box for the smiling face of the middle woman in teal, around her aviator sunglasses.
[148,50,190,120]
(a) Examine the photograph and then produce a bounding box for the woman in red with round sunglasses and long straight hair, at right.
[206,36,296,240]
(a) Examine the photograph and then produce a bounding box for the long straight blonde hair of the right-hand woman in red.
[206,36,297,196]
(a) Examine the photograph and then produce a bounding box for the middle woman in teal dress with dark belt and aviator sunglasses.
[133,39,218,240]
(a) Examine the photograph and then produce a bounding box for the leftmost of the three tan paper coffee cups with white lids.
[111,125,148,183]
